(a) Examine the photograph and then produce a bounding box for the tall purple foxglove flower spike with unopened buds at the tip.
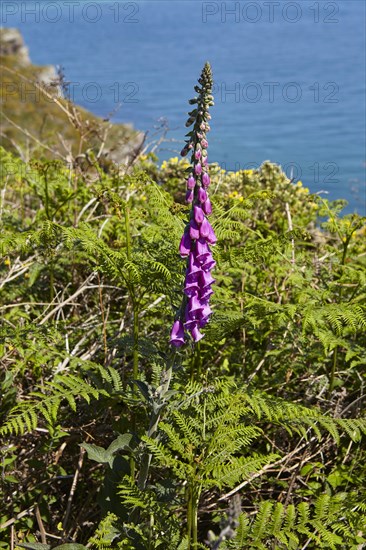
[170,63,217,347]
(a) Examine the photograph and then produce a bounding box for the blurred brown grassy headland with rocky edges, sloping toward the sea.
[0,27,145,164]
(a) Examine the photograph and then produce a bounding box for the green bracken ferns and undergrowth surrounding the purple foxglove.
[0,55,366,550]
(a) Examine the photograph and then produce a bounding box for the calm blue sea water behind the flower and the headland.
[1,0,366,214]
